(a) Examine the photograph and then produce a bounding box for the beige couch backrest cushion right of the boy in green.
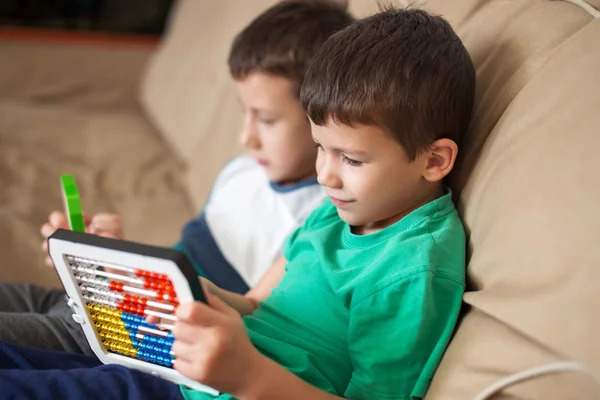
[420,0,600,400]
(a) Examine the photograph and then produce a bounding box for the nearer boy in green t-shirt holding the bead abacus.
[0,3,475,400]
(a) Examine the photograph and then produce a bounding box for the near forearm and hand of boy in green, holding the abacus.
[172,284,343,400]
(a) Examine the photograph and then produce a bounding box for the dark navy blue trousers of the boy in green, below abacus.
[0,343,183,400]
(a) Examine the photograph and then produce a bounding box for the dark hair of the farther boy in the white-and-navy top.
[228,0,354,91]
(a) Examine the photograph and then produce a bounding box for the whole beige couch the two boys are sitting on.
[0,0,600,400]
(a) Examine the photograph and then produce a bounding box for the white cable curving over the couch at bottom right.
[473,361,600,400]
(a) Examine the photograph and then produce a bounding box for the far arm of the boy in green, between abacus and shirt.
[200,256,287,317]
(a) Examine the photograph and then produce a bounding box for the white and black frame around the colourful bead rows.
[48,229,218,395]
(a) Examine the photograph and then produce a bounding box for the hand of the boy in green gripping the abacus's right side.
[173,291,263,394]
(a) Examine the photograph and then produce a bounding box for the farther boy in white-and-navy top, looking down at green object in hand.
[0,1,352,354]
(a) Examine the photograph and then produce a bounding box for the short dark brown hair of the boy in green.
[300,9,475,161]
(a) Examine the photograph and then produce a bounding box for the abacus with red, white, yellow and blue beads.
[48,229,218,394]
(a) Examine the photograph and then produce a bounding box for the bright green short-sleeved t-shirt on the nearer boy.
[182,193,465,400]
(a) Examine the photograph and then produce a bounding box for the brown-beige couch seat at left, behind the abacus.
[0,101,192,284]
